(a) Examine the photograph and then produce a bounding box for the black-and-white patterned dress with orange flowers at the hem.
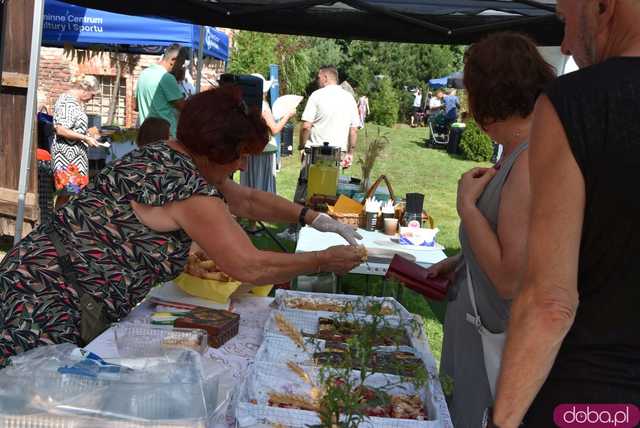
[51,94,89,194]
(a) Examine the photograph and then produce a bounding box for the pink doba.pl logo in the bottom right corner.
[553,404,640,428]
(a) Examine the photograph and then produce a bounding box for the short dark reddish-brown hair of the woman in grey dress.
[464,31,556,126]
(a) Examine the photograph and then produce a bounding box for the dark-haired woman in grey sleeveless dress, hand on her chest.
[429,33,555,428]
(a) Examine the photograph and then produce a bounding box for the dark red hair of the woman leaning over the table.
[177,85,270,165]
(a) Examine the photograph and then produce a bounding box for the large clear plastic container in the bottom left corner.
[0,344,216,428]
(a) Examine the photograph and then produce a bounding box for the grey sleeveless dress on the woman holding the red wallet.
[440,143,528,428]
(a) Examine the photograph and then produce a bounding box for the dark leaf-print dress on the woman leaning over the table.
[0,142,222,367]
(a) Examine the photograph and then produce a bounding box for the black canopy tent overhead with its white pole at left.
[14,0,571,242]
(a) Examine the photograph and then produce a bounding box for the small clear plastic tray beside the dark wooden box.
[113,323,208,357]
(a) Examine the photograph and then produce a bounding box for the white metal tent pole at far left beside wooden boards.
[13,0,44,243]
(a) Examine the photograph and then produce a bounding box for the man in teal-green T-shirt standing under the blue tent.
[136,44,185,137]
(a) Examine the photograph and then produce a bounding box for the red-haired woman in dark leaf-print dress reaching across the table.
[0,86,362,367]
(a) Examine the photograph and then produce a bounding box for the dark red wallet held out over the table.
[385,255,449,300]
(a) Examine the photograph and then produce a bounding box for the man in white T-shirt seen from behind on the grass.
[294,66,360,203]
